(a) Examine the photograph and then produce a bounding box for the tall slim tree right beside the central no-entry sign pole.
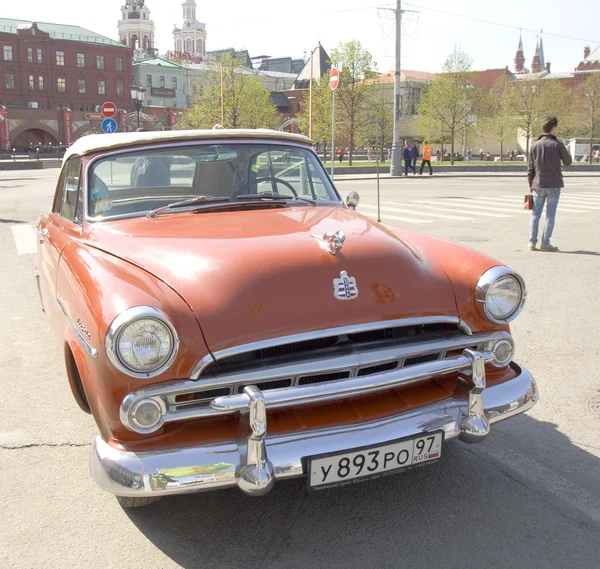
[331,40,377,166]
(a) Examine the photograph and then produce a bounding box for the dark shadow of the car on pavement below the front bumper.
[127,415,600,569]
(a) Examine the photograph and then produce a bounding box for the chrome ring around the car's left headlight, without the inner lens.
[104,306,179,379]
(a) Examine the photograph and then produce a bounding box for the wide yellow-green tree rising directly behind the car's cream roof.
[180,55,279,128]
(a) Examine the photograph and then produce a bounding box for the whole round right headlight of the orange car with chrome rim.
[475,267,526,324]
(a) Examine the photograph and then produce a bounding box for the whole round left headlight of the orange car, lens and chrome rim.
[105,306,179,378]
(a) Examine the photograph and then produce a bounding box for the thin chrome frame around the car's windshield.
[82,138,344,223]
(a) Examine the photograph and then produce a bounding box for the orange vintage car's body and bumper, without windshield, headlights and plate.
[36,131,537,504]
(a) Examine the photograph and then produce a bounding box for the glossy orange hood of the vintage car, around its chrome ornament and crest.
[87,206,458,352]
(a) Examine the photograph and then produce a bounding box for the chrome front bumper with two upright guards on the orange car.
[90,360,538,497]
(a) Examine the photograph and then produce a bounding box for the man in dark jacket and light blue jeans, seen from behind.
[527,117,573,252]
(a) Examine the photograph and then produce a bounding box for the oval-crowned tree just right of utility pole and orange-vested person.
[417,49,480,164]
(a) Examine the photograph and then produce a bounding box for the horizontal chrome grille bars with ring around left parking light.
[120,332,509,434]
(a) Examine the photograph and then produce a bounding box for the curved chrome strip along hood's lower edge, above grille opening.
[190,316,460,379]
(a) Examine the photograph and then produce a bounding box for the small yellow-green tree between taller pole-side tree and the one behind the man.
[476,76,515,159]
